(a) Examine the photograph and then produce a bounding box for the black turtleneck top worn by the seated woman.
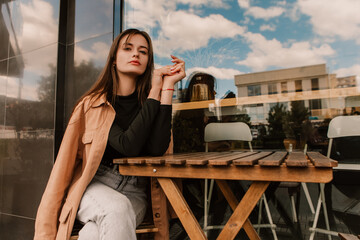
[101,91,172,167]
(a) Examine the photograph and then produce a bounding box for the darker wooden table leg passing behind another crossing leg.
[215,180,260,240]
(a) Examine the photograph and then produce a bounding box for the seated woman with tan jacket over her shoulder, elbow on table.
[34,29,185,240]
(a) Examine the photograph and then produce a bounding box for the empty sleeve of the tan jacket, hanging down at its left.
[34,103,84,240]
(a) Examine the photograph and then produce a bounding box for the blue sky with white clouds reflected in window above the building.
[125,0,360,97]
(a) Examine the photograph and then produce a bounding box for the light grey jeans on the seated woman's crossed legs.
[76,165,147,240]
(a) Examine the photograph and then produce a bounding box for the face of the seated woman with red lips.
[116,34,149,77]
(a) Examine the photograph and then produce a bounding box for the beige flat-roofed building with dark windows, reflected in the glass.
[235,64,360,124]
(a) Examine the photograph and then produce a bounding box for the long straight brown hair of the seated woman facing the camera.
[78,29,154,107]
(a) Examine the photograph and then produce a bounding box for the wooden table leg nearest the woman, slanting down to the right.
[158,178,207,240]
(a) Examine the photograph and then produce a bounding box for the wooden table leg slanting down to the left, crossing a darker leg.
[217,182,270,240]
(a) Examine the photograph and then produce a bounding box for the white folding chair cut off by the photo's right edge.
[310,116,360,240]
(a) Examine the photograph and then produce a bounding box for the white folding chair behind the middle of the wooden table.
[204,122,277,239]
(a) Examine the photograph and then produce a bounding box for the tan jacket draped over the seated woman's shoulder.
[34,96,115,240]
